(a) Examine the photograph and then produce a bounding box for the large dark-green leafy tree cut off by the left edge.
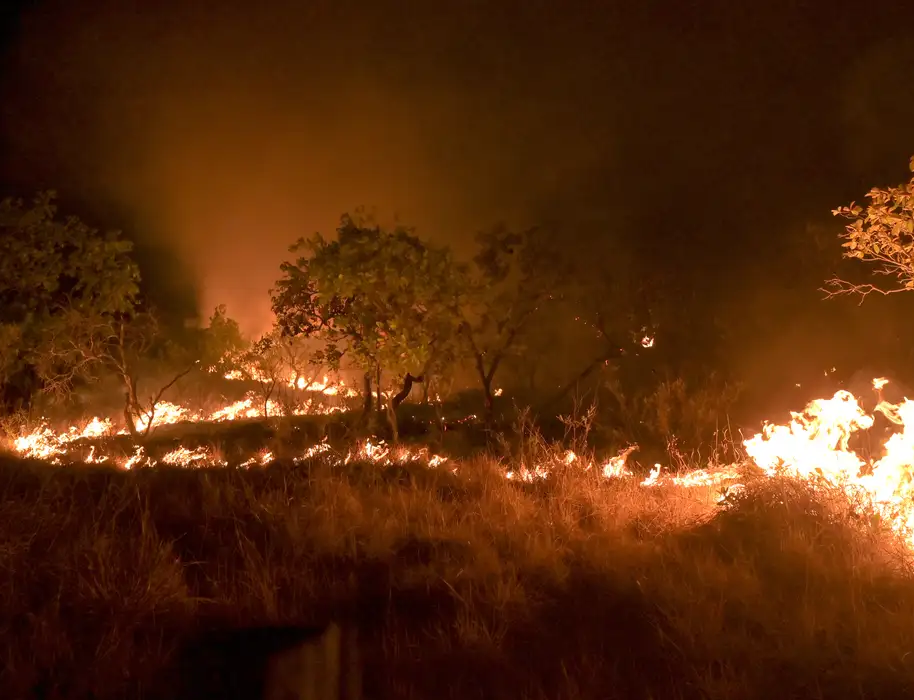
[0,192,139,412]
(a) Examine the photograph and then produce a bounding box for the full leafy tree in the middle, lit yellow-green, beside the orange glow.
[272,214,464,439]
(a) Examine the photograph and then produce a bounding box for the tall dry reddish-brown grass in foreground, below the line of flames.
[0,442,914,700]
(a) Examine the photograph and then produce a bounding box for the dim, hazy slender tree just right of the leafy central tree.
[460,224,567,421]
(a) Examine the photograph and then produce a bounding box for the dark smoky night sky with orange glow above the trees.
[0,0,914,404]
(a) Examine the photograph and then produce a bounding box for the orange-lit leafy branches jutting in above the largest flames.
[826,158,914,298]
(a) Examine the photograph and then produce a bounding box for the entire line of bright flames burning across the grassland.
[12,377,914,547]
